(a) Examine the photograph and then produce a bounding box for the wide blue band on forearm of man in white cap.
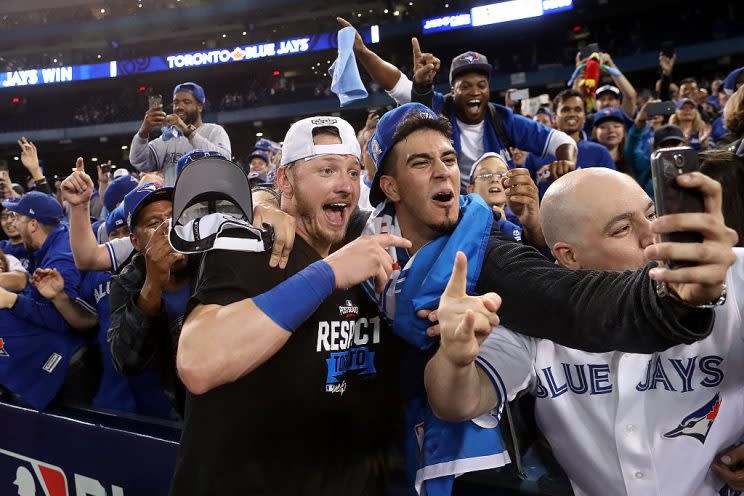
[253,260,336,332]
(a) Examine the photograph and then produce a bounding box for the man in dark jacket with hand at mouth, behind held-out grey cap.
[108,183,191,414]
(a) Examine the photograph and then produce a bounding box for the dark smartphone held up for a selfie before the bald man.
[651,146,705,269]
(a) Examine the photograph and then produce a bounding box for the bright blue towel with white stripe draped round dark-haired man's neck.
[362,195,510,496]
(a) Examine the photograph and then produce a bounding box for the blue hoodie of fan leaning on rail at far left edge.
[0,224,83,410]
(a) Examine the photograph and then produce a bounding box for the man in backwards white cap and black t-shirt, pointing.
[171,117,411,496]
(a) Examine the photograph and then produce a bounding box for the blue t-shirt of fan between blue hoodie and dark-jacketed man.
[78,272,173,419]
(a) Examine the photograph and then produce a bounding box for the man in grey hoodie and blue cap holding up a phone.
[129,83,232,186]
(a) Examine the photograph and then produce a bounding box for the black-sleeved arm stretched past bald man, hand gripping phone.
[476,173,737,353]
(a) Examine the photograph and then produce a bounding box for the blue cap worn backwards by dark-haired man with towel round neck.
[367,103,438,207]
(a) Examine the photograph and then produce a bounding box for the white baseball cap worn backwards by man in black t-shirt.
[281,116,362,166]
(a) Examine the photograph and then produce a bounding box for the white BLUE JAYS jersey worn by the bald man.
[476,248,744,496]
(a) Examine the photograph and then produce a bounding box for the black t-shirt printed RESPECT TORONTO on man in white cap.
[171,236,401,496]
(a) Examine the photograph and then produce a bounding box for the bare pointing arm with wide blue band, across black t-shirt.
[177,234,410,394]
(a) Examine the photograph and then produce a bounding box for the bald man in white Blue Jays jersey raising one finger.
[426,168,744,496]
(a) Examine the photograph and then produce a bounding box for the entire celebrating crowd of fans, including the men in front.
[0,20,744,495]
